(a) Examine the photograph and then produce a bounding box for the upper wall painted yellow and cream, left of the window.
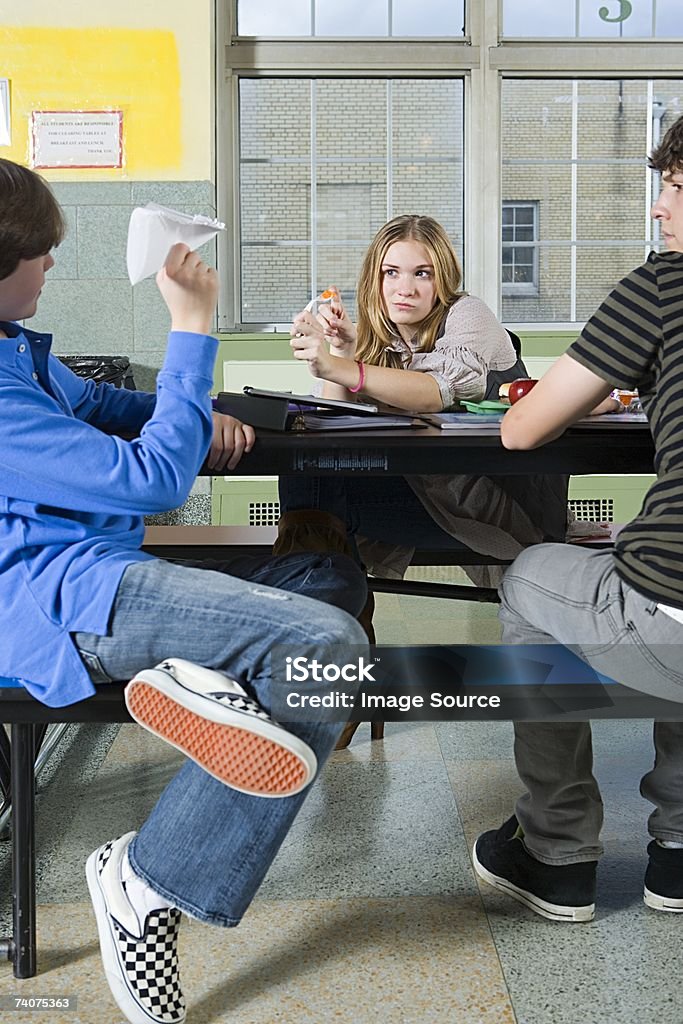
[0,0,214,181]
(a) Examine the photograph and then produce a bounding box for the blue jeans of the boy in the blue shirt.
[74,554,367,927]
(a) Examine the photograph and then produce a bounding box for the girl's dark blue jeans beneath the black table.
[279,473,468,551]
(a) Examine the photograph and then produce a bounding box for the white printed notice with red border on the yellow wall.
[31,111,123,168]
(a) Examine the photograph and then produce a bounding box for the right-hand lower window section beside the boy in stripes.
[502,79,683,323]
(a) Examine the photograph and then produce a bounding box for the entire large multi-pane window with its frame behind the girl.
[217,0,683,331]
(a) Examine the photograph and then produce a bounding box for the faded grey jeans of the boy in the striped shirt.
[500,544,683,864]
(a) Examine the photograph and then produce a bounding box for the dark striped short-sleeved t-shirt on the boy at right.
[567,252,683,608]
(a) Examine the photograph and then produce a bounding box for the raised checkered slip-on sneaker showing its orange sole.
[125,657,317,797]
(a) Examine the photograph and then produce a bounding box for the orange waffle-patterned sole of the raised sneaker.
[126,680,306,797]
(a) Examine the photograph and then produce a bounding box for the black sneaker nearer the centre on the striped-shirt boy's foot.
[472,815,597,922]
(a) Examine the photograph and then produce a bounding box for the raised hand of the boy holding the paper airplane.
[157,242,218,334]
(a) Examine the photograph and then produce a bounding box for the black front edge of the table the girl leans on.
[225,422,654,476]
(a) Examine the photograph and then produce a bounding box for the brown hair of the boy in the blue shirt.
[0,159,67,281]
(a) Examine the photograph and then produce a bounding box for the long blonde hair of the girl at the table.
[355,214,463,367]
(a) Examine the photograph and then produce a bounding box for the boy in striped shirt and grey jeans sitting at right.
[474,118,683,922]
